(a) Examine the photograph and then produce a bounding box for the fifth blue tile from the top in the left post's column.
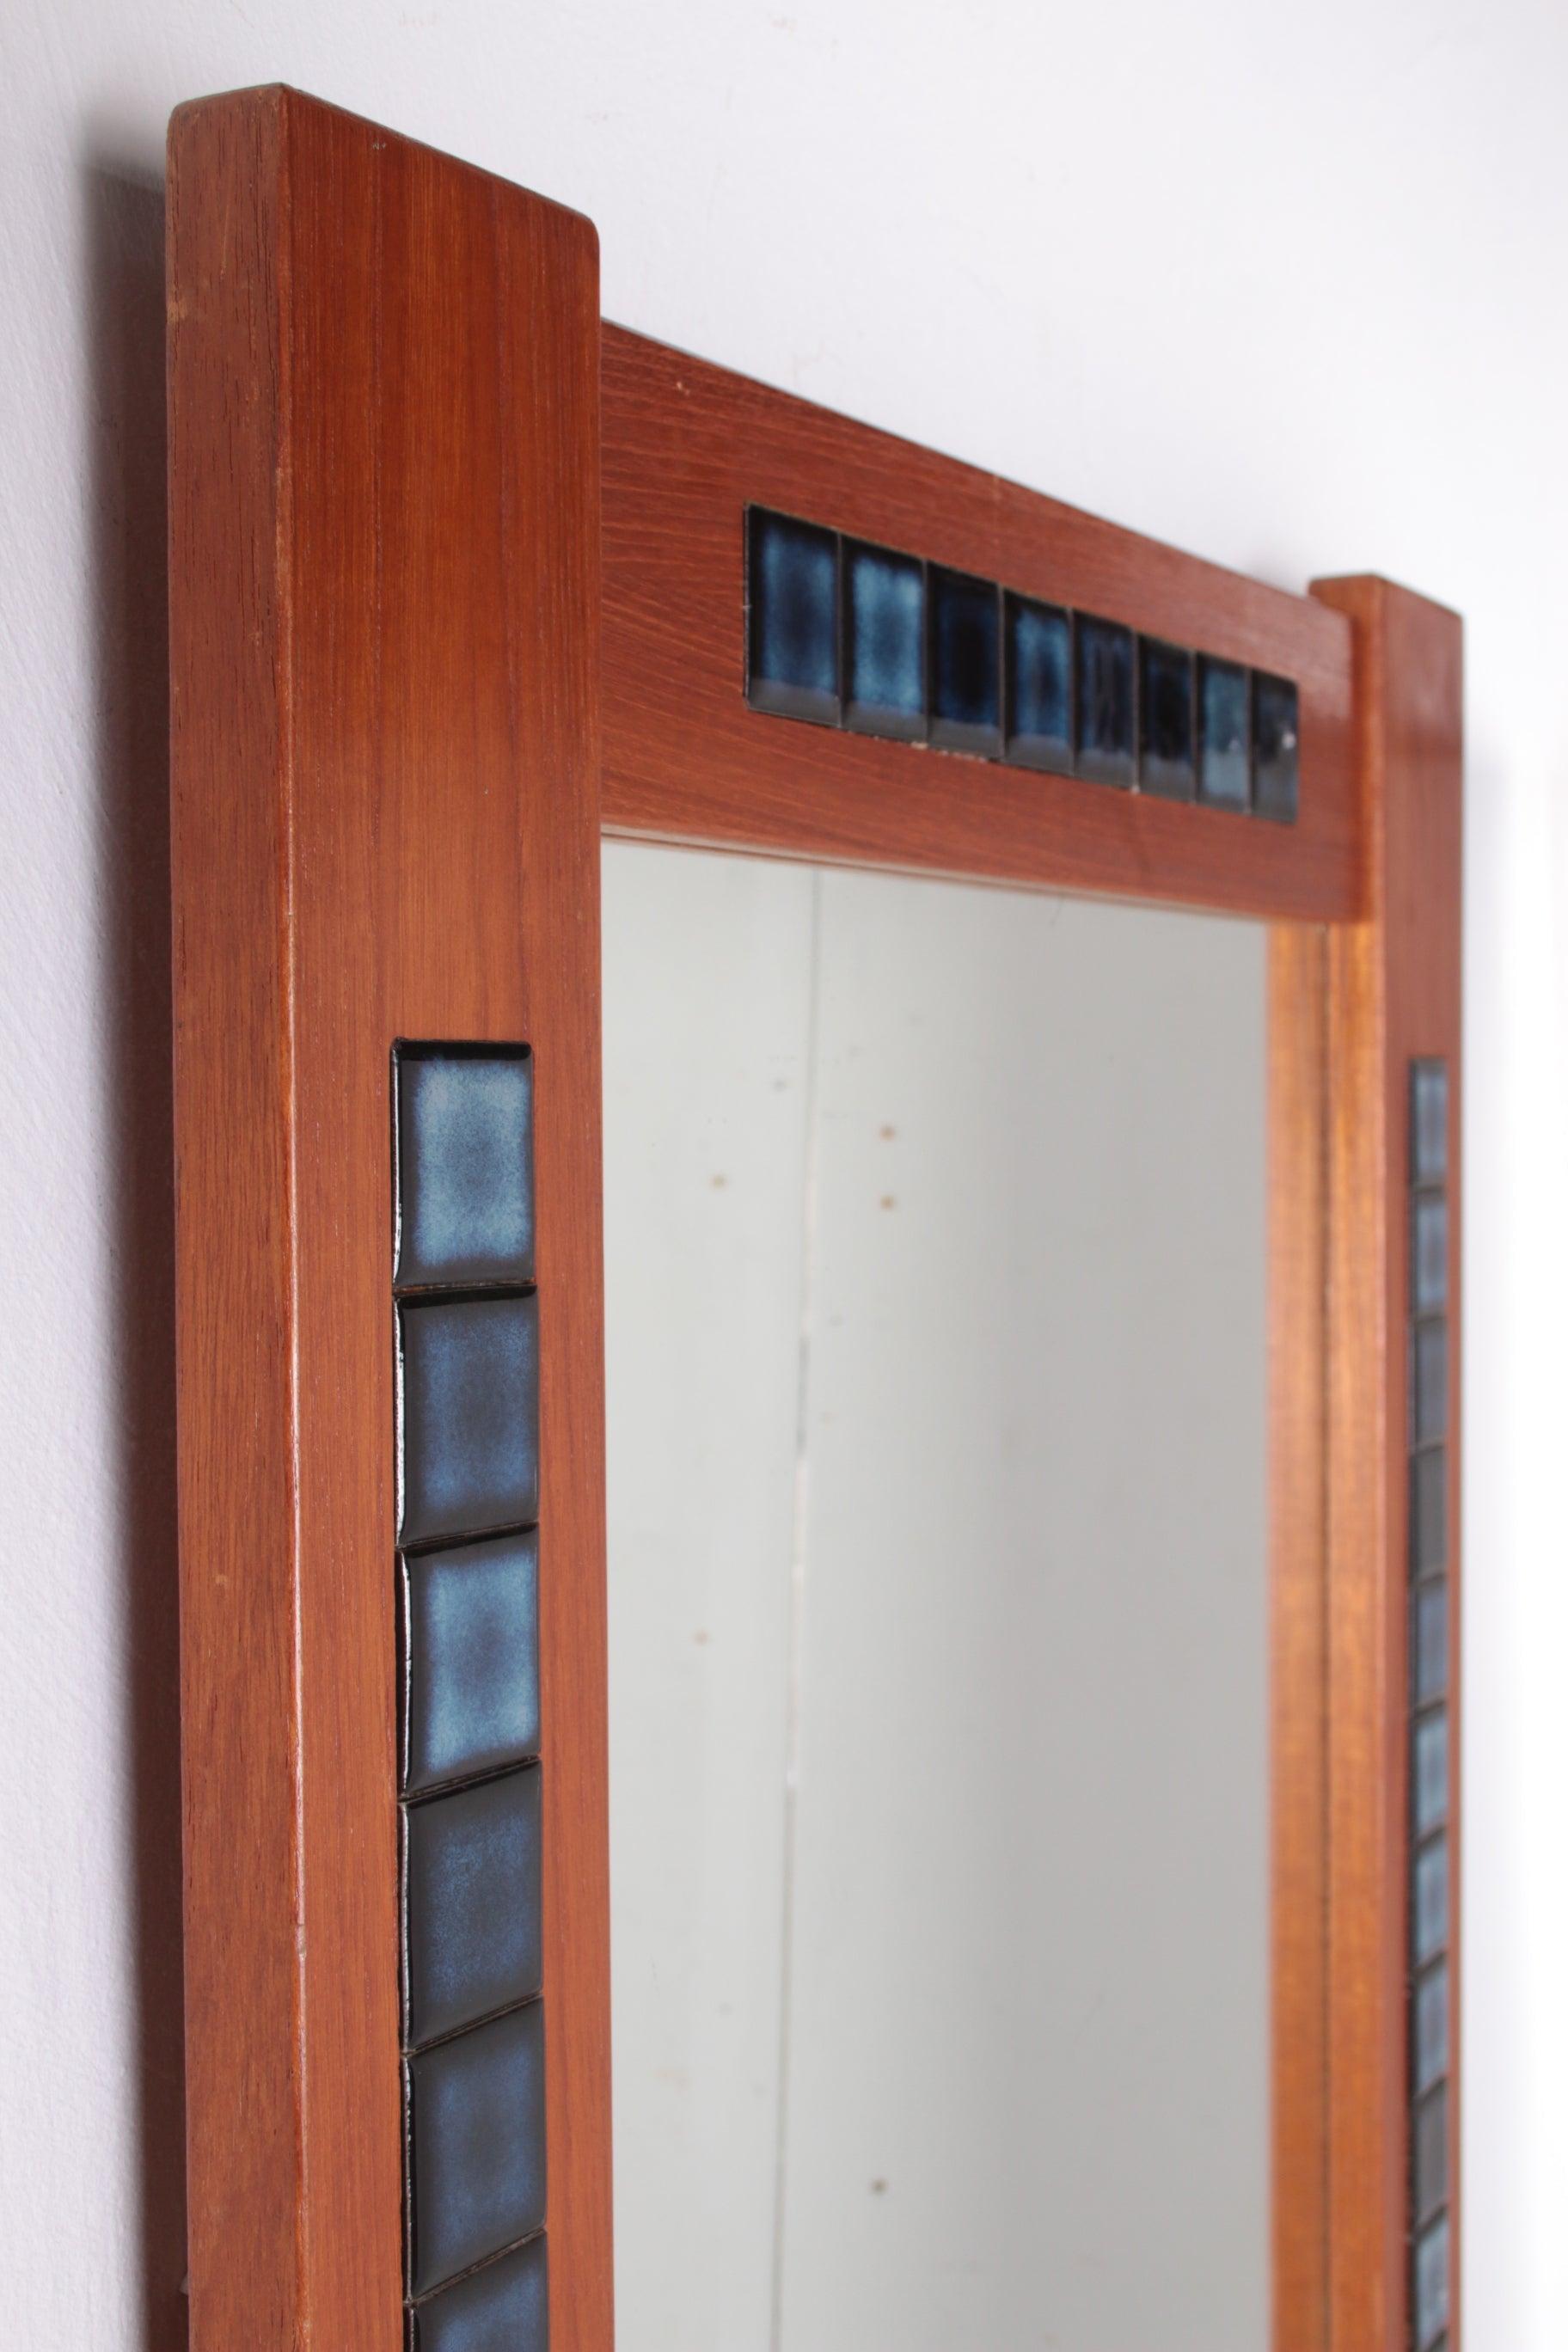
[404,2001,545,2295]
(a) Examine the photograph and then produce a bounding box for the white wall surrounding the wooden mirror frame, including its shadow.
[0,0,1568,2352]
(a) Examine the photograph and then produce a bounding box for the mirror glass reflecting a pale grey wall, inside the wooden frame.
[604,842,1270,2352]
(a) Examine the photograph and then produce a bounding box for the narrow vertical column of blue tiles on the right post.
[1408,1058,1450,2352]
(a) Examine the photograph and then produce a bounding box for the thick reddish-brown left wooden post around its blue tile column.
[169,89,611,2352]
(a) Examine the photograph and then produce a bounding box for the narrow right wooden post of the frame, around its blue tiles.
[1314,579,1462,2352]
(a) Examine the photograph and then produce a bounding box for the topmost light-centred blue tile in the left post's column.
[395,1047,534,1284]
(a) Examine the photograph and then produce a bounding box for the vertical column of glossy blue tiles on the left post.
[393,1044,548,2352]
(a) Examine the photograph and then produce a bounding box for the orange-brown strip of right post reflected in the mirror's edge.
[1270,924,1328,2352]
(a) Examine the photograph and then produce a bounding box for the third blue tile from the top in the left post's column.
[400,1528,538,1795]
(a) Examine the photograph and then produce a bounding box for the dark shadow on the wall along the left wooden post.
[83,160,186,2352]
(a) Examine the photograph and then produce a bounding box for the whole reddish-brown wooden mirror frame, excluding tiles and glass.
[169,89,1460,2352]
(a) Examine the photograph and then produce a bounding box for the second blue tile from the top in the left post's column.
[397,1296,538,1543]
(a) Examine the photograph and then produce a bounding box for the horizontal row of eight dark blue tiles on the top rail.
[748,505,1300,824]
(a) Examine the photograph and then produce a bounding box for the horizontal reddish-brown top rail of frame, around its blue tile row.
[604,327,1361,922]
